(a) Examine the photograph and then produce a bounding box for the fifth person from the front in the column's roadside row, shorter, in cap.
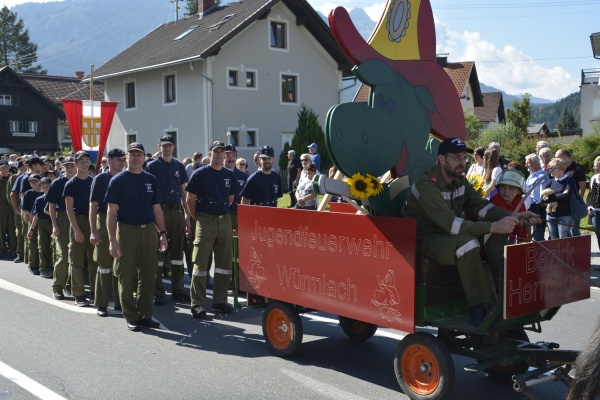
[27,178,54,279]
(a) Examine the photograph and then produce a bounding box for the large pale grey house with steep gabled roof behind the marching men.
[94,0,351,170]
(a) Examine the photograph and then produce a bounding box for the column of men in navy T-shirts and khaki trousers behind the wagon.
[0,135,283,331]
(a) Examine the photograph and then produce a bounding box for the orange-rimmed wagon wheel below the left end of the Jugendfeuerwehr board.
[263,301,303,358]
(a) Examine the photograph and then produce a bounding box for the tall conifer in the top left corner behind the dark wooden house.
[0,6,47,75]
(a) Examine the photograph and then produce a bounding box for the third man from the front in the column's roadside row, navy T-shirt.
[63,150,98,307]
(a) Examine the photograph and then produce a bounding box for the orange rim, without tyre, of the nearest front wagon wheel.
[400,344,440,395]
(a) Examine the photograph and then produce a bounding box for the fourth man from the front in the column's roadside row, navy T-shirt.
[46,157,77,300]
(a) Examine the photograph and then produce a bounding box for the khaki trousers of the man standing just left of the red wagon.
[190,213,233,307]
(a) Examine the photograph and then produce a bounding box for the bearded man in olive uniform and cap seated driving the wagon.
[402,138,539,326]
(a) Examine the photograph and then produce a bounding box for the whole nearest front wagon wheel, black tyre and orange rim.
[394,332,454,400]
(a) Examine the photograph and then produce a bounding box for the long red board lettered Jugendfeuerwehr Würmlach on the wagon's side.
[238,205,416,333]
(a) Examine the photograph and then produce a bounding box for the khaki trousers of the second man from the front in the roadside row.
[94,213,121,307]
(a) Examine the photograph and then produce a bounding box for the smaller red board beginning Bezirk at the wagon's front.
[504,235,591,318]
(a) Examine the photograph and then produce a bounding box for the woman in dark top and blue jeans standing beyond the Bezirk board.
[542,158,576,239]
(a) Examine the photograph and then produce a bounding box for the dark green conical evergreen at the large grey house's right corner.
[279,104,332,171]
